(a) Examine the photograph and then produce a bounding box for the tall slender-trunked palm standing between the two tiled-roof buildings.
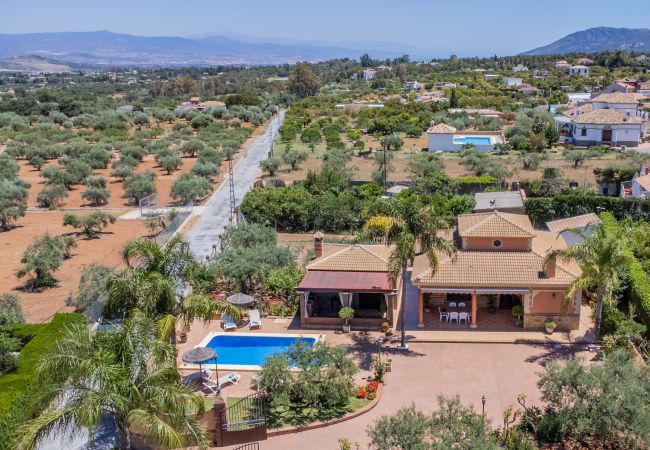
[364,206,454,349]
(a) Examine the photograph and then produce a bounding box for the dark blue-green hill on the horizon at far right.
[522,27,650,55]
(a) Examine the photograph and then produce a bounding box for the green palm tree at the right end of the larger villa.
[546,213,634,336]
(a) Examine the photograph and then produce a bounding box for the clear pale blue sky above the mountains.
[0,0,649,56]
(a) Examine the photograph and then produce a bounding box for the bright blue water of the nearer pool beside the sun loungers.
[202,335,316,366]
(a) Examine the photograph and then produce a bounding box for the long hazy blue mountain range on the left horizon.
[0,31,416,66]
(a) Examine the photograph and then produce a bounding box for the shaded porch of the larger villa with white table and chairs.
[417,287,531,331]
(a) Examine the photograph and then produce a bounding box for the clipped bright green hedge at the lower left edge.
[0,314,86,450]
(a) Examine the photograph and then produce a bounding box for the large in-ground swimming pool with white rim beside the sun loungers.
[194,333,323,370]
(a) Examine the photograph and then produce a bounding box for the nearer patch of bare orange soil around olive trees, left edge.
[0,211,148,322]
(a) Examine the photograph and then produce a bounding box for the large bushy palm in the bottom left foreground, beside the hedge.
[20,313,208,450]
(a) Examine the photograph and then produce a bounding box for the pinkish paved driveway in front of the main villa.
[237,343,588,450]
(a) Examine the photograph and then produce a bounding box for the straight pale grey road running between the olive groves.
[187,111,284,260]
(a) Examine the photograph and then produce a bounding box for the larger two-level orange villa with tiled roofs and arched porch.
[412,211,581,330]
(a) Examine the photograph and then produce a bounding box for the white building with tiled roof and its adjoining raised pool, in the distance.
[427,123,504,152]
